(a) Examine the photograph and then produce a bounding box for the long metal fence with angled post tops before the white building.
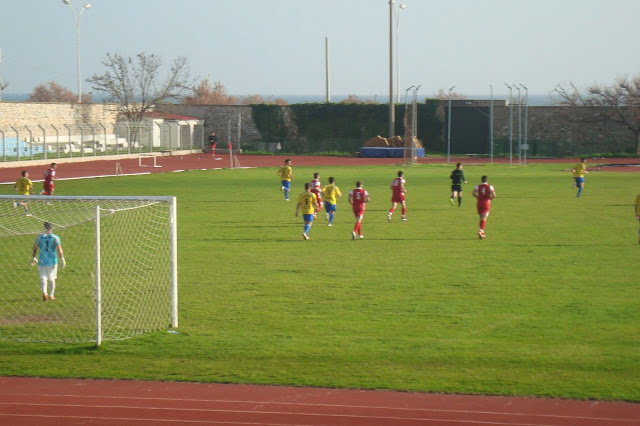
[0,121,204,162]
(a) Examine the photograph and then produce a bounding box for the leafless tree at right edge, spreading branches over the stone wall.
[552,75,640,155]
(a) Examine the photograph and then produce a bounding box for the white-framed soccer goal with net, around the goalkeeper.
[0,195,178,345]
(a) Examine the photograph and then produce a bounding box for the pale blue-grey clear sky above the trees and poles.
[0,0,640,98]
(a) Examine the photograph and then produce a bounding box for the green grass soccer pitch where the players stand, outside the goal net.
[0,164,640,401]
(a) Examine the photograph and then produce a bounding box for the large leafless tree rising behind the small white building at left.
[87,53,195,122]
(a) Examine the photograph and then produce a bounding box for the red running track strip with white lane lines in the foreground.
[0,377,640,426]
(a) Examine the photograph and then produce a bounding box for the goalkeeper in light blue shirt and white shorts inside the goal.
[31,222,67,302]
